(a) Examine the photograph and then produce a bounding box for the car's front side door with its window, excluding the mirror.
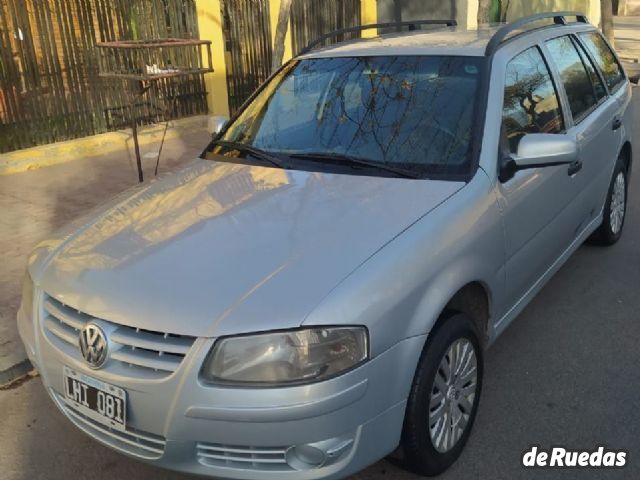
[497,46,579,304]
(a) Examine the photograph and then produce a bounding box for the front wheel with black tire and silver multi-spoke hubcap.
[401,313,483,476]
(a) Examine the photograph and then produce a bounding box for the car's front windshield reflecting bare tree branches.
[202,56,482,175]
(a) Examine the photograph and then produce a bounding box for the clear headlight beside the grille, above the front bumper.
[202,327,369,386]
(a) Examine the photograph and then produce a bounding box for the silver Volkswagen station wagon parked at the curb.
[18,13,632,480]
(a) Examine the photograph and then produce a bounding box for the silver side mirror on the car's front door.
[500,133,578,182]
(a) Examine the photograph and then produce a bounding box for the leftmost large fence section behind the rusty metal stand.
[0,0,207,152]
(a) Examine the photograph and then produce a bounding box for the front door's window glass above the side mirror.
[502,47,564,153]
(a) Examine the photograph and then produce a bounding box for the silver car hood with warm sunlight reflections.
[30,160,464,336]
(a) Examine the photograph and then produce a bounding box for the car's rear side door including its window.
[545,35,620,235]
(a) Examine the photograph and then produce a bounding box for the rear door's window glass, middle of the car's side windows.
[547,37,598,121]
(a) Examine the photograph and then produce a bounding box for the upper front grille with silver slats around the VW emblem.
[42,295,195,378]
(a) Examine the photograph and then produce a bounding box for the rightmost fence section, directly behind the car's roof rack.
[291,0,360,55]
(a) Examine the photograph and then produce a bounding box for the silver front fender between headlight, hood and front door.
[304,170,505,357]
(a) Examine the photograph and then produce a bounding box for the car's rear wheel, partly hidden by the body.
[588,159,628,246]
